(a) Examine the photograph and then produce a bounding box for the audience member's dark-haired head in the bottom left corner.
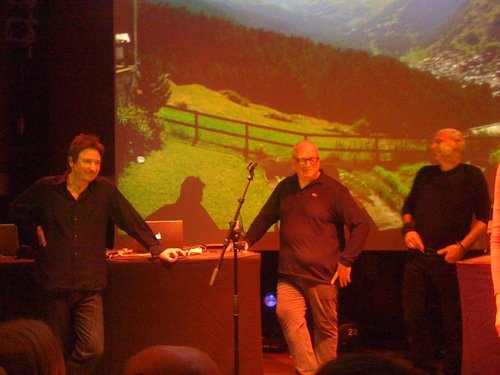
[0,319,66,375]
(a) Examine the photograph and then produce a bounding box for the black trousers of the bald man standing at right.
[403,251,462,374]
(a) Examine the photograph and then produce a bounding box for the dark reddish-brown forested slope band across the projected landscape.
[137,2,498,137]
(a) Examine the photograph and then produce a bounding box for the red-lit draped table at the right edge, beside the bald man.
[457,255,500,375]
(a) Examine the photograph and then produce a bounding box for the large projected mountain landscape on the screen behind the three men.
[114,0,500,250]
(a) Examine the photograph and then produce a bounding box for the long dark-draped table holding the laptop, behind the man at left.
[0,251,262,375]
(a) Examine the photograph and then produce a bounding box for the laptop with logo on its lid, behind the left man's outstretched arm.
[114,220,184,253]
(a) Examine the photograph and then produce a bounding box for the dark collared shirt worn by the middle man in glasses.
[246,172,369,283]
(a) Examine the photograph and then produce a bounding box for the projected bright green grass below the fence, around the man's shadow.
[118,137,273,229]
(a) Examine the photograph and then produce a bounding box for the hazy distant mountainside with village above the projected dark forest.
[166,0,500,95]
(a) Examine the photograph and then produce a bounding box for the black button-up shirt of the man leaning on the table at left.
[11,174,162,291]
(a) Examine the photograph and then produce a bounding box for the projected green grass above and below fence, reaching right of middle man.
[118,84,418,234]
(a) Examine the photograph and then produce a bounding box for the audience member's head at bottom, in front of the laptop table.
[123,345,220,375]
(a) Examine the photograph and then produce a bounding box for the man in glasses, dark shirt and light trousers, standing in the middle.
[246,141,368,374]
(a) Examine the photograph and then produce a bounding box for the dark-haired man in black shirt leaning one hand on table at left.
[11,134,177,374]
